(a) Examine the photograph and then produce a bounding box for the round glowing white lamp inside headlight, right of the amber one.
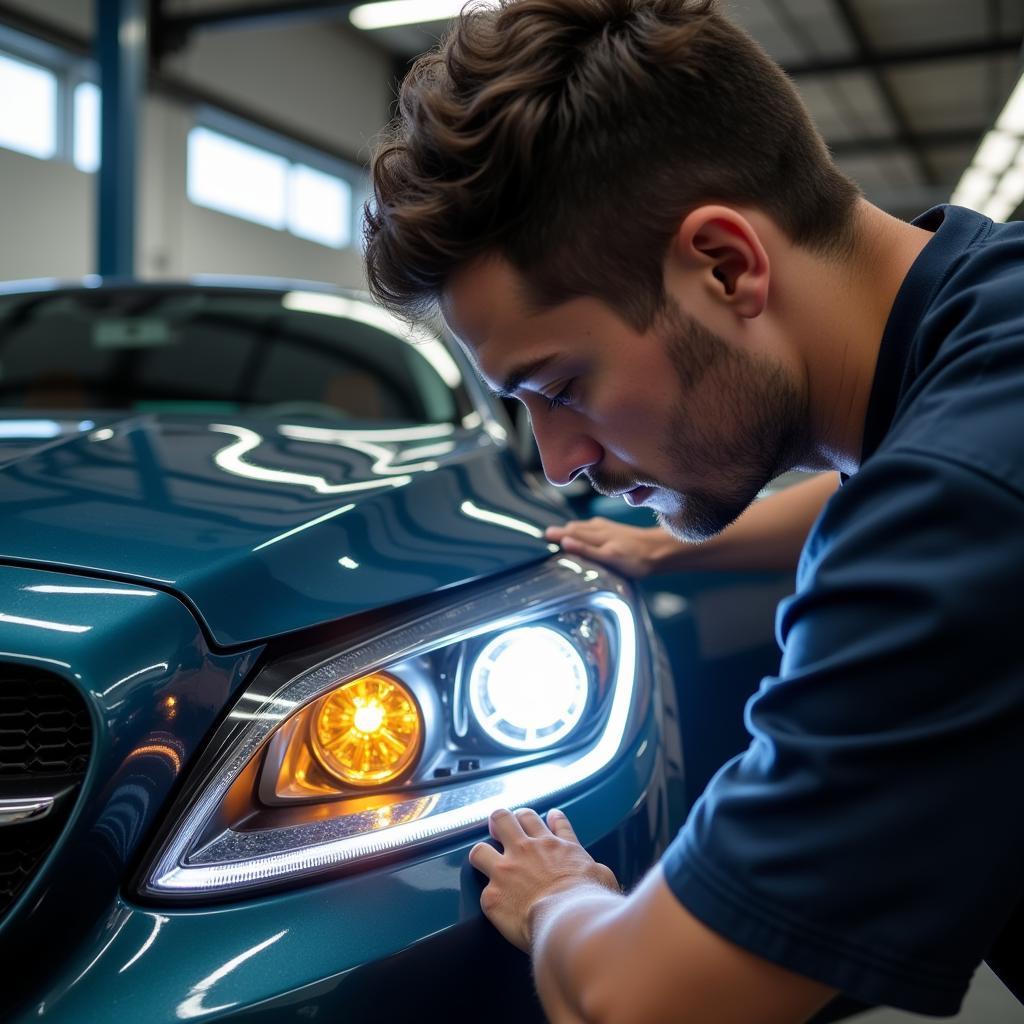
[469,626,590,751]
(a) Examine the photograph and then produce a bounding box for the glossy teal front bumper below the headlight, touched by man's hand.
[11,700,680,1024]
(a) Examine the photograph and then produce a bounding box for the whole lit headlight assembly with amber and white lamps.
[139,559,639,899]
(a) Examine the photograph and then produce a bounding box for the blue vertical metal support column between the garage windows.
[96,0,148,276]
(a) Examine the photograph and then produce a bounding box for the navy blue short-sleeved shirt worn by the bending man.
[663,207,1024,1015]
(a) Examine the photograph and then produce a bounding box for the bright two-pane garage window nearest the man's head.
[186,125,352,249]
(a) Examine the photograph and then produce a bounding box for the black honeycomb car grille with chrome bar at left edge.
[0,664,92,918]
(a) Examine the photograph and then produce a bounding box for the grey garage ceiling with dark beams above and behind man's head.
[154,0,1024,217]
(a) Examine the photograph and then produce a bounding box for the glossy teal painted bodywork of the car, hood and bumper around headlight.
[0,282,680,1022]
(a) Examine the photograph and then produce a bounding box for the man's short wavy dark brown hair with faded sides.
[366,0,859,329]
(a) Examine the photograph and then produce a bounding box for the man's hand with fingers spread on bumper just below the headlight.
[469,808,618,952]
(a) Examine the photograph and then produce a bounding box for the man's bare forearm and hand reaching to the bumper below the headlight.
[469,807,835,1024]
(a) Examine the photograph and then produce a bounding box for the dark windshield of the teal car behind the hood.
[0,287,472,424]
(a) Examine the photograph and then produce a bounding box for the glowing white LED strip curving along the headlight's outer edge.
[147,577,637,894]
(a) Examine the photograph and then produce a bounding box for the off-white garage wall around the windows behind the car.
[0,0,391,287]
